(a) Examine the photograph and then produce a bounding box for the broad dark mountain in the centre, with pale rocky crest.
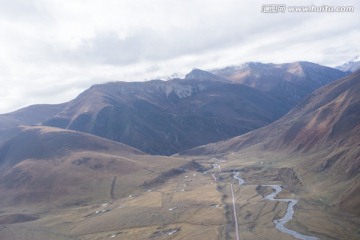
[38,76,290,155]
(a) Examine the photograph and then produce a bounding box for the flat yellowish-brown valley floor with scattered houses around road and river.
[0,155,360,240]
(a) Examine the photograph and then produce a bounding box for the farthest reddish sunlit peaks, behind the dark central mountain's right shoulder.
[212,62,346,106]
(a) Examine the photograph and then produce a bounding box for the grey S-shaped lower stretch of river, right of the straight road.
[263,185,319,240]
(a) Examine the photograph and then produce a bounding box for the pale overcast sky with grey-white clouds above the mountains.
[0,0,360,113]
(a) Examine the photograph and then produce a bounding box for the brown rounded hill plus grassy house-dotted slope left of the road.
[0,126,227,240]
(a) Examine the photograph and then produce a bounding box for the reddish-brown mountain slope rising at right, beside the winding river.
[184,71,360,215]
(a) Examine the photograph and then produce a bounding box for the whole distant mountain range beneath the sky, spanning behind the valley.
[0,62,345,155]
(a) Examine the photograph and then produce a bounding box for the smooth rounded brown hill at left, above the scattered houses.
[0,126,191,207]
